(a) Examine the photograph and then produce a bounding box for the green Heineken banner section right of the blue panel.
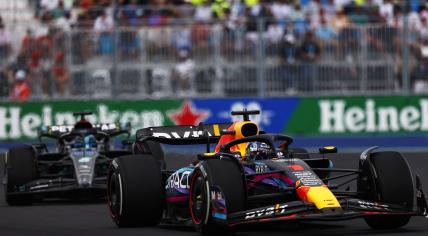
[284,96,428,135]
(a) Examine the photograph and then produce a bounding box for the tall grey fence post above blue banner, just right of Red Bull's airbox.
[256,17,266,97]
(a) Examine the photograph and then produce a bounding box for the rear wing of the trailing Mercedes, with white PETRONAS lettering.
[38,122,131,139]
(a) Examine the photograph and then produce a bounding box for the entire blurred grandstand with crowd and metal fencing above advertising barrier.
[0,0,428,101]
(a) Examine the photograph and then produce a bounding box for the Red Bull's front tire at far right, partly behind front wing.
[358,151,414,229]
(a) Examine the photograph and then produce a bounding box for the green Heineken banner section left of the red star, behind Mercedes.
[0,100,181,140]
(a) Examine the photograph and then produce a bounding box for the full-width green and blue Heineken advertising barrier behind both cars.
[0,96,428,146]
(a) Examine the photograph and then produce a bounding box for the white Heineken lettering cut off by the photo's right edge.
[318,99,428,133]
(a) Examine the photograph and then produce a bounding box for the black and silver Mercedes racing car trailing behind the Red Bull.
[3,112,131,205]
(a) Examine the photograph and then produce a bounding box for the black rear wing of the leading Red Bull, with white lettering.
[136,123,232,145]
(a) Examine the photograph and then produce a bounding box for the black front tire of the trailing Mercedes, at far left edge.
[5,147,37,206]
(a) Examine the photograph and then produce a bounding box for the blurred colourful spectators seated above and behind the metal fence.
[0,0,428,97]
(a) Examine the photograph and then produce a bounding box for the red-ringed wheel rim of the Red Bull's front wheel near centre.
[190,173,207,224]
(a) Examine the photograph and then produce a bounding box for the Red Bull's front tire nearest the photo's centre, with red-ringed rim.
[189,159,246,235]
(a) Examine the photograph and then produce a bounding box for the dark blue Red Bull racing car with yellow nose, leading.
[108,111,427,234]
